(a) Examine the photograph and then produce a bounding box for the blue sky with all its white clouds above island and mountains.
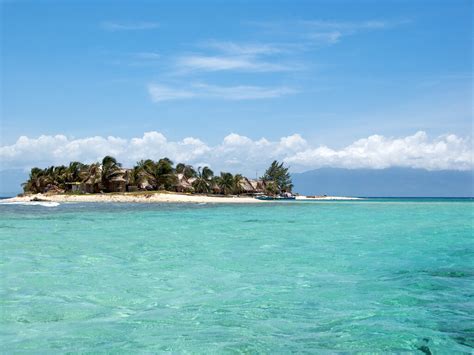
[0,0,473,175]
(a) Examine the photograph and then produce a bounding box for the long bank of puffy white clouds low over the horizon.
[0,132,474,177]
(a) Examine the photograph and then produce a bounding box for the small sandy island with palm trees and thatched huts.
[4,156,355,203]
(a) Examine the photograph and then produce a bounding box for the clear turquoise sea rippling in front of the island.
[0,200,474,354]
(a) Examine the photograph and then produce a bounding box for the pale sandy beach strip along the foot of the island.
[2,192,360,204]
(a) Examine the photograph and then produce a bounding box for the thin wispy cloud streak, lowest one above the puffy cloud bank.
[148,84,296,102]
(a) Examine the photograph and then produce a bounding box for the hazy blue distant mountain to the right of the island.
[292,168,474,197]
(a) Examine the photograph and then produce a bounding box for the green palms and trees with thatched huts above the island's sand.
[23,156,293,195]
